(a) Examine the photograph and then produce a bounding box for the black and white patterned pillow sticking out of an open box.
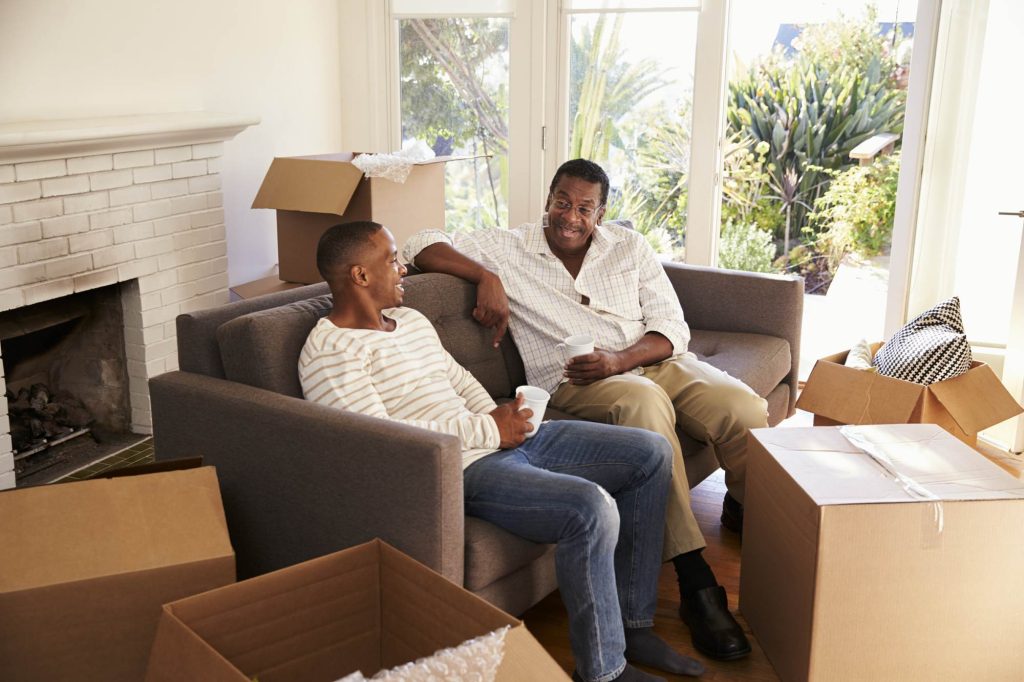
[873,296,971,384]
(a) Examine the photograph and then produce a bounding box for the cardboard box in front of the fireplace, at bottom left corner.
[0,467,234,682]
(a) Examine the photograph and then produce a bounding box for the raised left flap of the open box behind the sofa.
[253,154,362,216]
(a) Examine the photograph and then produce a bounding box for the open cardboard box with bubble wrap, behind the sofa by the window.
[253,152,455,284]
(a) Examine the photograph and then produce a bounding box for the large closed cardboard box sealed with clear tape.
[739,424,1024,682]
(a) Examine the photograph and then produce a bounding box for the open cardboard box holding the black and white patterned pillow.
[797,343,1024,446]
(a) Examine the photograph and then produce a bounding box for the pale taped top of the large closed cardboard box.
[753,424,1024,505]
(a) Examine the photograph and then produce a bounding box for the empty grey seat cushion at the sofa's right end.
[689,330,793,397]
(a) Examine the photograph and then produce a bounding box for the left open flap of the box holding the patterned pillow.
[797,352,925,424]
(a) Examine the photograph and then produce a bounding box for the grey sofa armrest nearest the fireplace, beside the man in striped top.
[150,372,464,585]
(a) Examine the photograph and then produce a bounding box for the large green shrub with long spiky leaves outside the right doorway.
[723,8,905,249]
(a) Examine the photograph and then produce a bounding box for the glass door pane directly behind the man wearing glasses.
[558,0,700,260]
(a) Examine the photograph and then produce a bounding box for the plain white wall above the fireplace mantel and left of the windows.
[0,0,343,285]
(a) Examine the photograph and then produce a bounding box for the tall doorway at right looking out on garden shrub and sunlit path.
[718,0,927,379]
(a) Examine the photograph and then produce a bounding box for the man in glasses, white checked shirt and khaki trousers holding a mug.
[403,159,767,660]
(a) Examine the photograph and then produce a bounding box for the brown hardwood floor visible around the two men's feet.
[522,469,778,681]
